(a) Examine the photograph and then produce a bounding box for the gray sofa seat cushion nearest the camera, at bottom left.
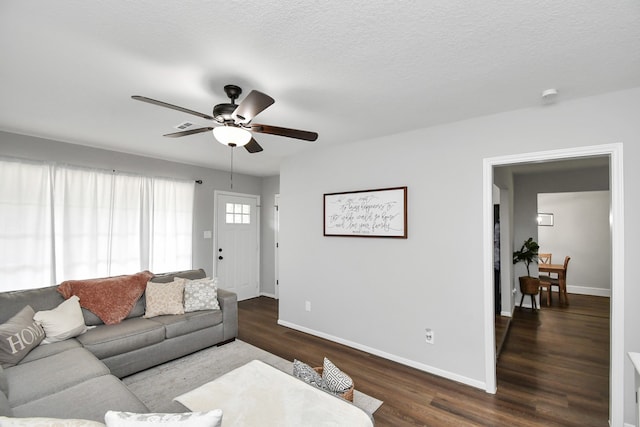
[13,375,149,421]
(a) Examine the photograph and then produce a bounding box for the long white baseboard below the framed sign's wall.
[278,319,486,390]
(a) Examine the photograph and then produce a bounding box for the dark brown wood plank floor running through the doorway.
[239,295,609,427]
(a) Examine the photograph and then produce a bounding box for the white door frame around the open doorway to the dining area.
[483,143,625,426]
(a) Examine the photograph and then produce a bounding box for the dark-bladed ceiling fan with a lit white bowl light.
[131,85,318,153]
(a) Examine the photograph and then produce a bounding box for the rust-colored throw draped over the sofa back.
[58,271,153,325]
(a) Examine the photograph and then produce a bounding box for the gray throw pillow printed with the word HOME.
[0,305,44,368]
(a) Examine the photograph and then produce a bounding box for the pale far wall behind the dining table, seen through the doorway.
[538,191,611,296]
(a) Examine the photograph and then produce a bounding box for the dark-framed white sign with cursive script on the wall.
[324,187,407,239]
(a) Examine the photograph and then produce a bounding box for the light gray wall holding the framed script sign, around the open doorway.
[279,89,640,422]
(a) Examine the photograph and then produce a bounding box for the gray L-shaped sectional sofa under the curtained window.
[0,269,238,422]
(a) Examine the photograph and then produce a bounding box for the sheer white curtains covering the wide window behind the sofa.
[0,159,195,290]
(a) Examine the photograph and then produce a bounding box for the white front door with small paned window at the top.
[214,192,260,301]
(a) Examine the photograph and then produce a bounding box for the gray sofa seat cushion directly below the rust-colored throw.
[76,317,165,359]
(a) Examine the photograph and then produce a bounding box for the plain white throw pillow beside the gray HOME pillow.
[33,295,87,344]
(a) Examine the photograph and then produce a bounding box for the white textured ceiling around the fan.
[0,0,640,176]
